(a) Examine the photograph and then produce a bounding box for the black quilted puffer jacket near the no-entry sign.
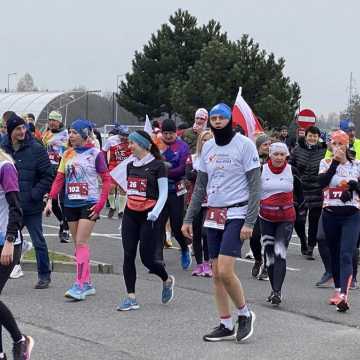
[289,140,326,208]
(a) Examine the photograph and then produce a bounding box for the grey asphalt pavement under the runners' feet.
[1,212,360,360]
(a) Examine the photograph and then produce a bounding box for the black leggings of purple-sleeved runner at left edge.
[0,245,22,353]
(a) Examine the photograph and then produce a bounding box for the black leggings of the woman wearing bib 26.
[121,207,168,294]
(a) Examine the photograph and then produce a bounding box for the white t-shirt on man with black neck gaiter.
[199,134,260,219]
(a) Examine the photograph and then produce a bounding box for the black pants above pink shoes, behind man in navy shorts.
[193,208,209,265]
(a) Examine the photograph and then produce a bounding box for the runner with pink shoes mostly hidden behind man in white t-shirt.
[186,131,213,277]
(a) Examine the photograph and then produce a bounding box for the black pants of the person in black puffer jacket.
[294,207,322,249]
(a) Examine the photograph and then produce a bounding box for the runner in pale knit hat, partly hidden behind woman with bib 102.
[42,111,70,243]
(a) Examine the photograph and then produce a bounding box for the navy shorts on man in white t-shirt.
[207,219,245,259]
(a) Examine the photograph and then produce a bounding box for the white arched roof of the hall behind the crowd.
[0,91,65,119]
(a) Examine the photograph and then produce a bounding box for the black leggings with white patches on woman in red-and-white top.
[260,219,294,291]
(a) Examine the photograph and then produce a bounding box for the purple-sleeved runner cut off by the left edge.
[0,150,34,360]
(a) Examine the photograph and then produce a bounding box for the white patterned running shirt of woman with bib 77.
[319,159,360,209]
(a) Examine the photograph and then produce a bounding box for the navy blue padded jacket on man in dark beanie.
[1,133,53,215]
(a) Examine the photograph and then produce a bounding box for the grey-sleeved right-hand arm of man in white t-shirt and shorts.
[244,168,261,229]
